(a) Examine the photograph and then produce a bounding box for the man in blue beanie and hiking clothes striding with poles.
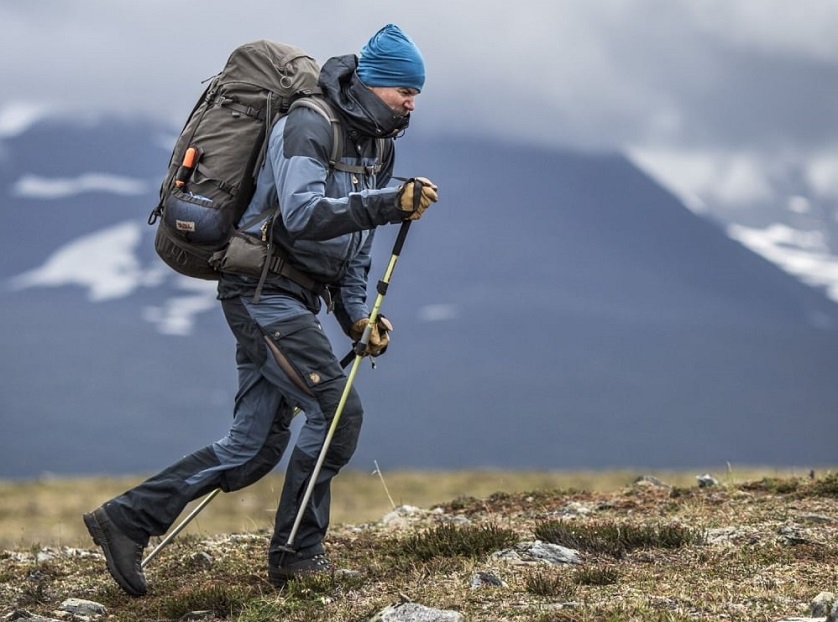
[84,24,437,596]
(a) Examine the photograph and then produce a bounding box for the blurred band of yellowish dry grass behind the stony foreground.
[0,467,805,549]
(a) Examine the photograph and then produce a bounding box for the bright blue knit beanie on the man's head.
[357,24,425,91]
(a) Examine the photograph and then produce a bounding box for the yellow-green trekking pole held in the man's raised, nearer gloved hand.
[279,220,413,553]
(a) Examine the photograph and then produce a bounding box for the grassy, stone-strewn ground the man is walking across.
[0,471,838,622]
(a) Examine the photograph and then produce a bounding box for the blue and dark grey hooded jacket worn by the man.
[219,55,409,332]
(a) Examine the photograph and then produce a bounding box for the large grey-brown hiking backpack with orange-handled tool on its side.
[148,40,328,280]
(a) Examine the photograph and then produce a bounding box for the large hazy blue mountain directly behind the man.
[0,114,838,477]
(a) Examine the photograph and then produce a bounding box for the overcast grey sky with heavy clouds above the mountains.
[0,0,838,207]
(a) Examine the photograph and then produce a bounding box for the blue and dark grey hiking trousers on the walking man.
[105,294,363,565]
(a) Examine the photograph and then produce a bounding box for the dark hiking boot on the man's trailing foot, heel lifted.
[84,508,146,596]
